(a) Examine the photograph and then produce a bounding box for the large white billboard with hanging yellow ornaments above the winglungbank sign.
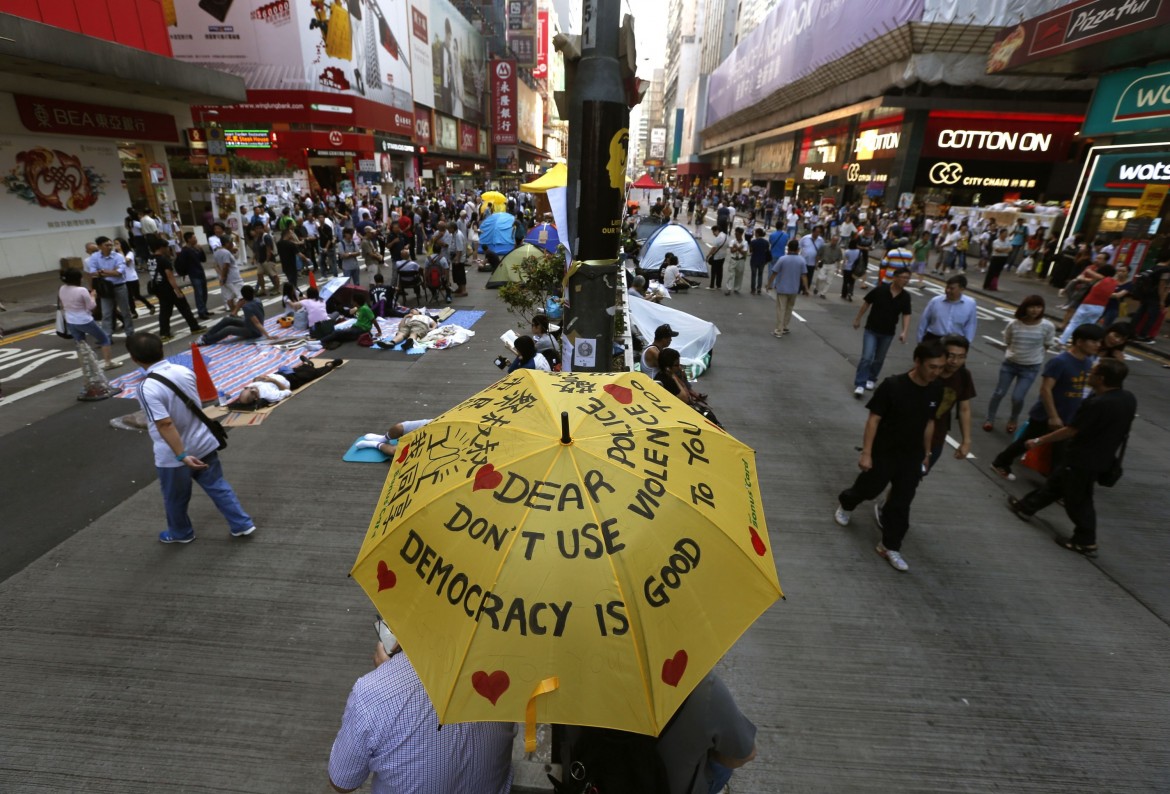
[171,0,412,132]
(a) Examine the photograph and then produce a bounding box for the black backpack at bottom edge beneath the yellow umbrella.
[549,727,670,794]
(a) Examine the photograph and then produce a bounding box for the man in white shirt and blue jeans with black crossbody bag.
[126,331,256,543]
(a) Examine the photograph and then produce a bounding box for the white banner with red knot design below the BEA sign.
[0,136,130,236]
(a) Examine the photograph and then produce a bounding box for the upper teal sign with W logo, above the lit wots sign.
[1081,61,1170,136]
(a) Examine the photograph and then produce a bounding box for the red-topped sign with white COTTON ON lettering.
[922,111,1083,163]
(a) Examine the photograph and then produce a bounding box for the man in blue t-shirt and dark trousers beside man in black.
[991,325,1104,479]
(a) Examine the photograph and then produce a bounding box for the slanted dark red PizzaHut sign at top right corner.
[987,0,1170,74]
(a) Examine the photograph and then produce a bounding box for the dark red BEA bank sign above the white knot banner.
[13,94,179,143]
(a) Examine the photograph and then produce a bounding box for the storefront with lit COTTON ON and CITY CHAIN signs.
[914,111,1083,206]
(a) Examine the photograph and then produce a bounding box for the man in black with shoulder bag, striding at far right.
[1007,359,1137,557]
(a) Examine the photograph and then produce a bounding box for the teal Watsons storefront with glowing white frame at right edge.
[1066,62,1170,267]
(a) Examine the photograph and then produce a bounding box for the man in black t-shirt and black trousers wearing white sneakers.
[833,341,947,571]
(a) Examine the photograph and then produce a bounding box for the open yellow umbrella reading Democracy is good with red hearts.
[352,369,780,744]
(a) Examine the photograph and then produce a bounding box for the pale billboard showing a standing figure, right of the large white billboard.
[410,0,488,124]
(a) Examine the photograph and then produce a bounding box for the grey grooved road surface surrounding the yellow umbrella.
[0,245,1170,794]
